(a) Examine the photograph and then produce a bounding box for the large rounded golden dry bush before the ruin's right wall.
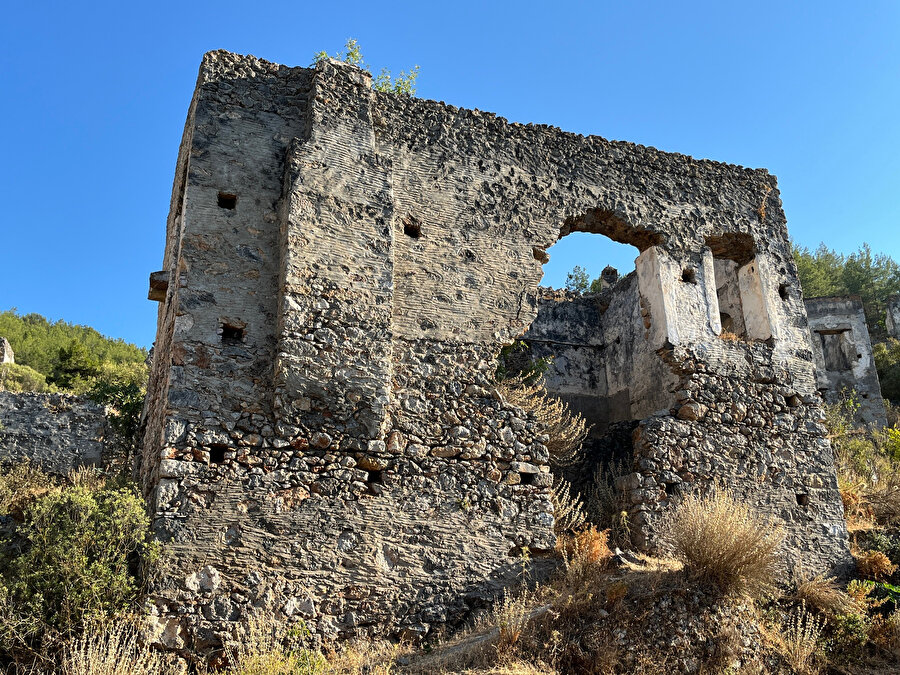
[663,486,784,597]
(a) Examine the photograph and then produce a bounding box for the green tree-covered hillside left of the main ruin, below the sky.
[0,309,147,379]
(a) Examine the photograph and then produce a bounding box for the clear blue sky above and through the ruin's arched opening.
[0,0,900,346]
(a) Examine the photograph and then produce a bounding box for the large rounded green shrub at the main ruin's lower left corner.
[0,470,157,655]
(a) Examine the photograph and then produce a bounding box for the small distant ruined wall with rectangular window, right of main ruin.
[805,296,887,427]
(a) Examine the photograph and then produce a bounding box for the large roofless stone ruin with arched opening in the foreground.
[139,51,849,649]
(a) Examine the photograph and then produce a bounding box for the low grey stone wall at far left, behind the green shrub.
[0,391,112,475]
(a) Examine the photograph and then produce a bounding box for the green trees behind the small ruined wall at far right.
[793,244,900,341]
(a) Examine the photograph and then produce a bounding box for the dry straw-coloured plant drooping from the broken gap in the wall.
[498,377,589,462]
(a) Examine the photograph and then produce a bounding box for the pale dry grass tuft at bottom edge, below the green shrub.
[58,623,171,675]
